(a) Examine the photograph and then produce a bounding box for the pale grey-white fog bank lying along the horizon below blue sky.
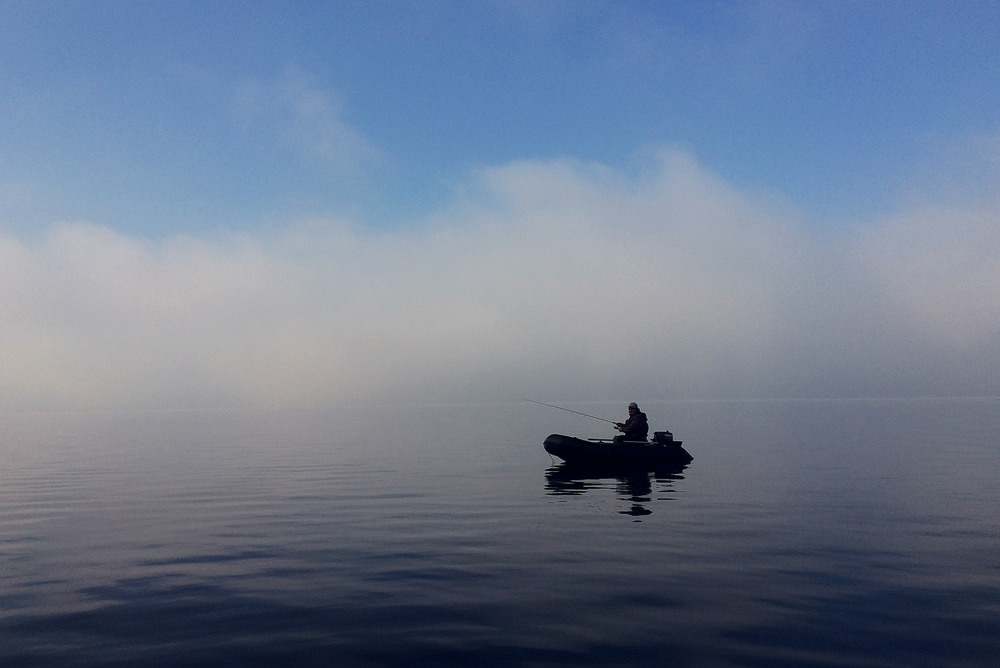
[0,151,1000,408]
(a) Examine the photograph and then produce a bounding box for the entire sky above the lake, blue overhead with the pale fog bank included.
[0,0,1000,407]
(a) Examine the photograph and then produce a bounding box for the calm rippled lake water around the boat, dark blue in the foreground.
[0,398,1000,668]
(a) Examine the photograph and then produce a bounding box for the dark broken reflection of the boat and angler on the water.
[545,463,687,517]
